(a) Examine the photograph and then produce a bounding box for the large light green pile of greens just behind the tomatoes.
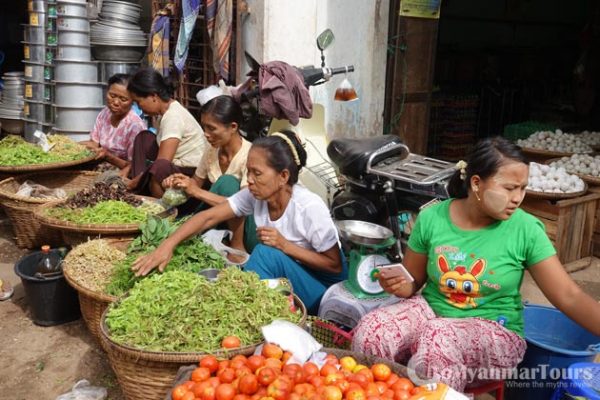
[106,267,302,353]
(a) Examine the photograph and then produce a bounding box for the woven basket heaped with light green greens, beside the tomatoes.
[101,267,306,400]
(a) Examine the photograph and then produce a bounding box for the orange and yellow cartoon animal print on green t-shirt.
[437,254,486,308]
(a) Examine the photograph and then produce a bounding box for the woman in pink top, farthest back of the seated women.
[84,74,146,176]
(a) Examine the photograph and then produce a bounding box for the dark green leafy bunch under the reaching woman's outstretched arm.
[106,216,227,296]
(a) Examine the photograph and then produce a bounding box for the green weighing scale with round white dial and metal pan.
[336,220,396,299]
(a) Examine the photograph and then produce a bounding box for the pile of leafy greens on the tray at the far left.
[0,135,92,166]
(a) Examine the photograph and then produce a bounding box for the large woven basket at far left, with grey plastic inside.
[0,171,98,248]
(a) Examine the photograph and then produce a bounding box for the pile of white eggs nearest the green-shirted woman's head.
[527,163,585,193]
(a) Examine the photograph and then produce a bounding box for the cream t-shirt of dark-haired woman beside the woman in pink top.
[156,101,208,167]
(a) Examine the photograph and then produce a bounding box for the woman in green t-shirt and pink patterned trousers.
[352,137,600,391]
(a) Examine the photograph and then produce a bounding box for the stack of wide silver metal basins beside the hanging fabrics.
[90,0,147,62]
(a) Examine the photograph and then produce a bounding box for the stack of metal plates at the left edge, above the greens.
[0,72,24,135]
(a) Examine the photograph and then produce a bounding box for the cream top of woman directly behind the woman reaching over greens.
[196,138,252,187]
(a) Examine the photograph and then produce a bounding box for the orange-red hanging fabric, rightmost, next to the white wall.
[206,0,233,80]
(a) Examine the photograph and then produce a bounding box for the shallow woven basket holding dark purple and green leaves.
[34,198,177,246]
